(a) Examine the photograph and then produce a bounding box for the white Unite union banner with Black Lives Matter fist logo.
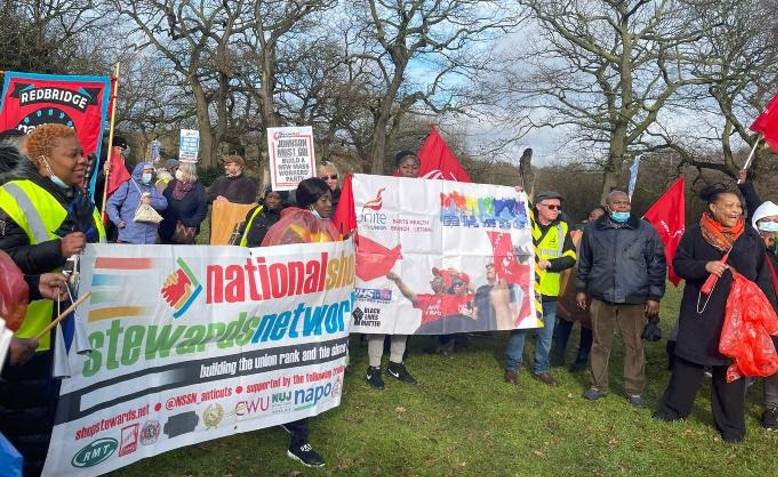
[352,174,543,334]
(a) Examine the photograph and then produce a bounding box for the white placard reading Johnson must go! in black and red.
[267,126,316,191]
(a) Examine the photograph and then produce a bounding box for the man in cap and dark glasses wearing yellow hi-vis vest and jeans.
[505,191,576,386]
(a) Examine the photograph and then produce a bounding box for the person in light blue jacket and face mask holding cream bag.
[105,162,167,244]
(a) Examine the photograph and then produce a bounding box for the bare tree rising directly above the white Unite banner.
[350,0,518,174]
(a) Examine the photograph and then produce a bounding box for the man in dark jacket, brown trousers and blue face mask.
[575,191,666,408]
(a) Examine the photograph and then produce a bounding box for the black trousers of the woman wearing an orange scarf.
[654,357,746,442]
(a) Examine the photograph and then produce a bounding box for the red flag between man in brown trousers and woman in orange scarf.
[643,176,686,286]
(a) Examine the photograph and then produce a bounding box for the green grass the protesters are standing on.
[104,288,778,477]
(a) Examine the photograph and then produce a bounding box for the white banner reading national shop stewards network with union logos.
[44,241,354,476]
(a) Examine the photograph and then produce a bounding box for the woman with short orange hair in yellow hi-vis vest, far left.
[0,124,105,476]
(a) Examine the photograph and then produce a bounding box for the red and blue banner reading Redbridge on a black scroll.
[0,71,111,189]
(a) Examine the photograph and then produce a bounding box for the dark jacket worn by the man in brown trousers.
[575,215,667,305]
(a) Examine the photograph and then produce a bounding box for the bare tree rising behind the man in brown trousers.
[494,0,706,201]
